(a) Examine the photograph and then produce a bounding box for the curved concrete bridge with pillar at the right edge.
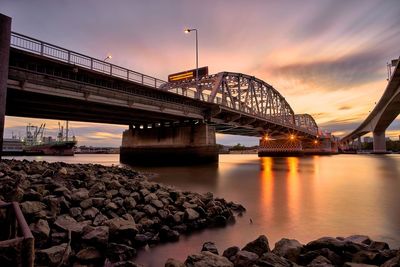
[340,57,400,153]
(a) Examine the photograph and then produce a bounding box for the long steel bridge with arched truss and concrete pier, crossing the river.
[0,16,334,165]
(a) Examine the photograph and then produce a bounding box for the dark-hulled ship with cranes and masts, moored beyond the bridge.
[22,121,77,156]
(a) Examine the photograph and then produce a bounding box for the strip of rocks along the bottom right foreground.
[165,235,400,267]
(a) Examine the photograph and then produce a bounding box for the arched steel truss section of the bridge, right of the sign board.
[161,72,318,137]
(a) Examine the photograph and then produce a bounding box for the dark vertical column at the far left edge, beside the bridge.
[0,14,11,160]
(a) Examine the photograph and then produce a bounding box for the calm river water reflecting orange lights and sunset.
[5,155,400,266]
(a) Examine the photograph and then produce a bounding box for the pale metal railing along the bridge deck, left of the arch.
[11,32,165,88]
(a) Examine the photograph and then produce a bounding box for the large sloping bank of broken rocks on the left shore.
[0,160,245,266]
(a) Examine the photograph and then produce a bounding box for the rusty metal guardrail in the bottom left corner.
[0,201,35,267]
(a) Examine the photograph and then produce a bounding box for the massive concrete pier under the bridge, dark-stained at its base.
[120,124,218,165]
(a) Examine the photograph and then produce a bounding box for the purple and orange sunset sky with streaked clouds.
[0,0,400,146]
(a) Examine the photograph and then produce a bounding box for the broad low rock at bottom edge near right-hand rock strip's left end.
[185,251,233,267]
